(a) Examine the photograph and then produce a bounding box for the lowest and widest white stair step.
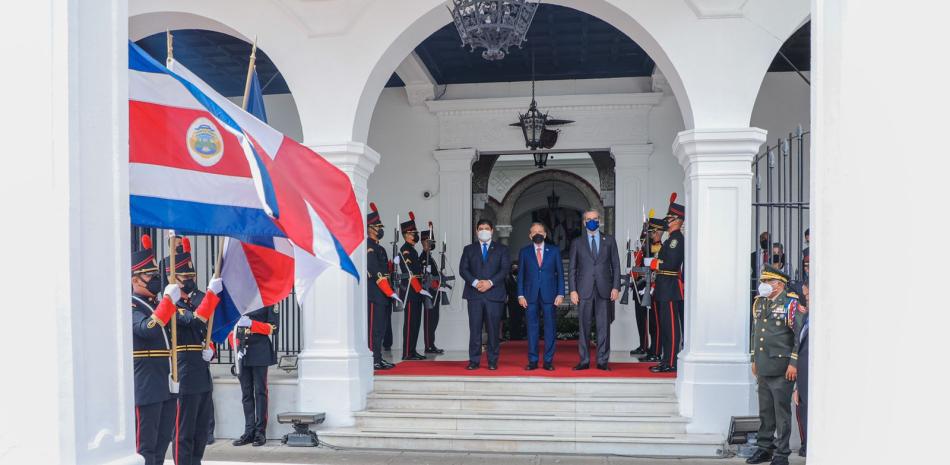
[320,428,723,457]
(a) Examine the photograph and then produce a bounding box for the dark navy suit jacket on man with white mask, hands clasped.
[459,241,511,302]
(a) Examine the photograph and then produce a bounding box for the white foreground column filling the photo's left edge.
[0,0,142,465]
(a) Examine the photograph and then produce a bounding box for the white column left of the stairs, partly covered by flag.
[297,142,379,427]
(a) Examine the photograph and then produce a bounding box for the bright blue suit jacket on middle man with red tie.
[518,243,564,304]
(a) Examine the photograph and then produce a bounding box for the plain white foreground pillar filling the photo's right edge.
[808,0,950,465]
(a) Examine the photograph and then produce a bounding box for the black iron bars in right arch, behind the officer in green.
[750,126,809,296]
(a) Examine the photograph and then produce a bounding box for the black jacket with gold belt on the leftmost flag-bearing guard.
[132,294,172,405]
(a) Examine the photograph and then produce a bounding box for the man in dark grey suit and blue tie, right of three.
[568,210,621,370]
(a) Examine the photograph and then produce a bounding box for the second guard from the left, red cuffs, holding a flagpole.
[162,237,222,465]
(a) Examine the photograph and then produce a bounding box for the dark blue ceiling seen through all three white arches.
[137,3,811,97]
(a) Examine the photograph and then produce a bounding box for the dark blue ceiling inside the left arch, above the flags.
[136,29,290,97]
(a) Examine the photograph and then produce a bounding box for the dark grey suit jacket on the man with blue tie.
[568,232,622,299]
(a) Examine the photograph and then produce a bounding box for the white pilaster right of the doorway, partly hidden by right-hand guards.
[610,144,653,351]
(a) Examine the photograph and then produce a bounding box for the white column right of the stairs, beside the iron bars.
[673,128,766,433]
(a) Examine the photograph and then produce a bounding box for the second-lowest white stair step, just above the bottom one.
[354,410,687,434]
